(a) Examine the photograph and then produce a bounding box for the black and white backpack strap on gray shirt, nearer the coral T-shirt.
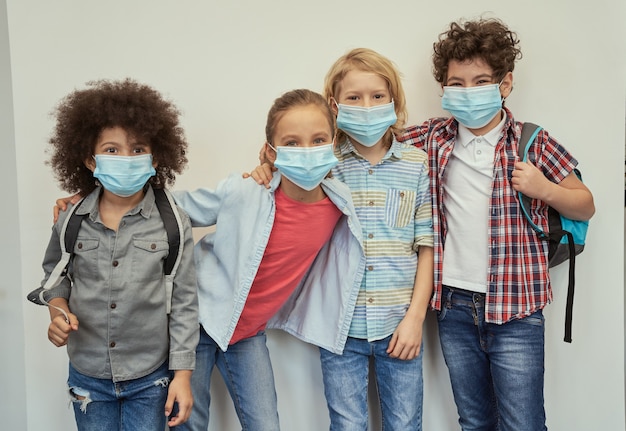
[152,188,184,314]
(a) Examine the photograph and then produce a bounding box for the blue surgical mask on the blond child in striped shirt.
[337,101,398,147]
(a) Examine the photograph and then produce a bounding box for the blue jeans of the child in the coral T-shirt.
[175,326,280,431]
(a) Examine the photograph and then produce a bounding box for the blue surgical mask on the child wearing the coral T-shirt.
[270,144,339,191]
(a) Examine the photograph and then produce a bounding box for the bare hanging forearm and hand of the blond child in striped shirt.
[387,246,434,360]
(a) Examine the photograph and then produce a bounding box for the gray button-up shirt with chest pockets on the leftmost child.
[42,187,198,382]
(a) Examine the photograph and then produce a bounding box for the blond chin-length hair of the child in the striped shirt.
[324,48,408,147]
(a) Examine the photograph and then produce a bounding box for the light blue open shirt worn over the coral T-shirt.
[173,172,365,353]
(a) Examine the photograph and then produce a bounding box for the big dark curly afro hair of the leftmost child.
[47,78,187,196]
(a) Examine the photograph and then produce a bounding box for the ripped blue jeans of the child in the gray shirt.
[67,362,171,431]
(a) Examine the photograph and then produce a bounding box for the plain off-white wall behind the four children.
[0,0,626,431]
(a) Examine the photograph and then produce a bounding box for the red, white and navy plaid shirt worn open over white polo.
[398,108,578,324]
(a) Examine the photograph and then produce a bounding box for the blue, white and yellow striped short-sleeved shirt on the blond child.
[332,139,433,341]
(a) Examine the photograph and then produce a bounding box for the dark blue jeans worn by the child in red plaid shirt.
[438,286,547,431]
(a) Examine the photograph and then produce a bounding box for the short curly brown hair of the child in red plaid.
[433,18,522,85]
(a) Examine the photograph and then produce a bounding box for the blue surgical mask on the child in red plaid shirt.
[441,84,502,129]
